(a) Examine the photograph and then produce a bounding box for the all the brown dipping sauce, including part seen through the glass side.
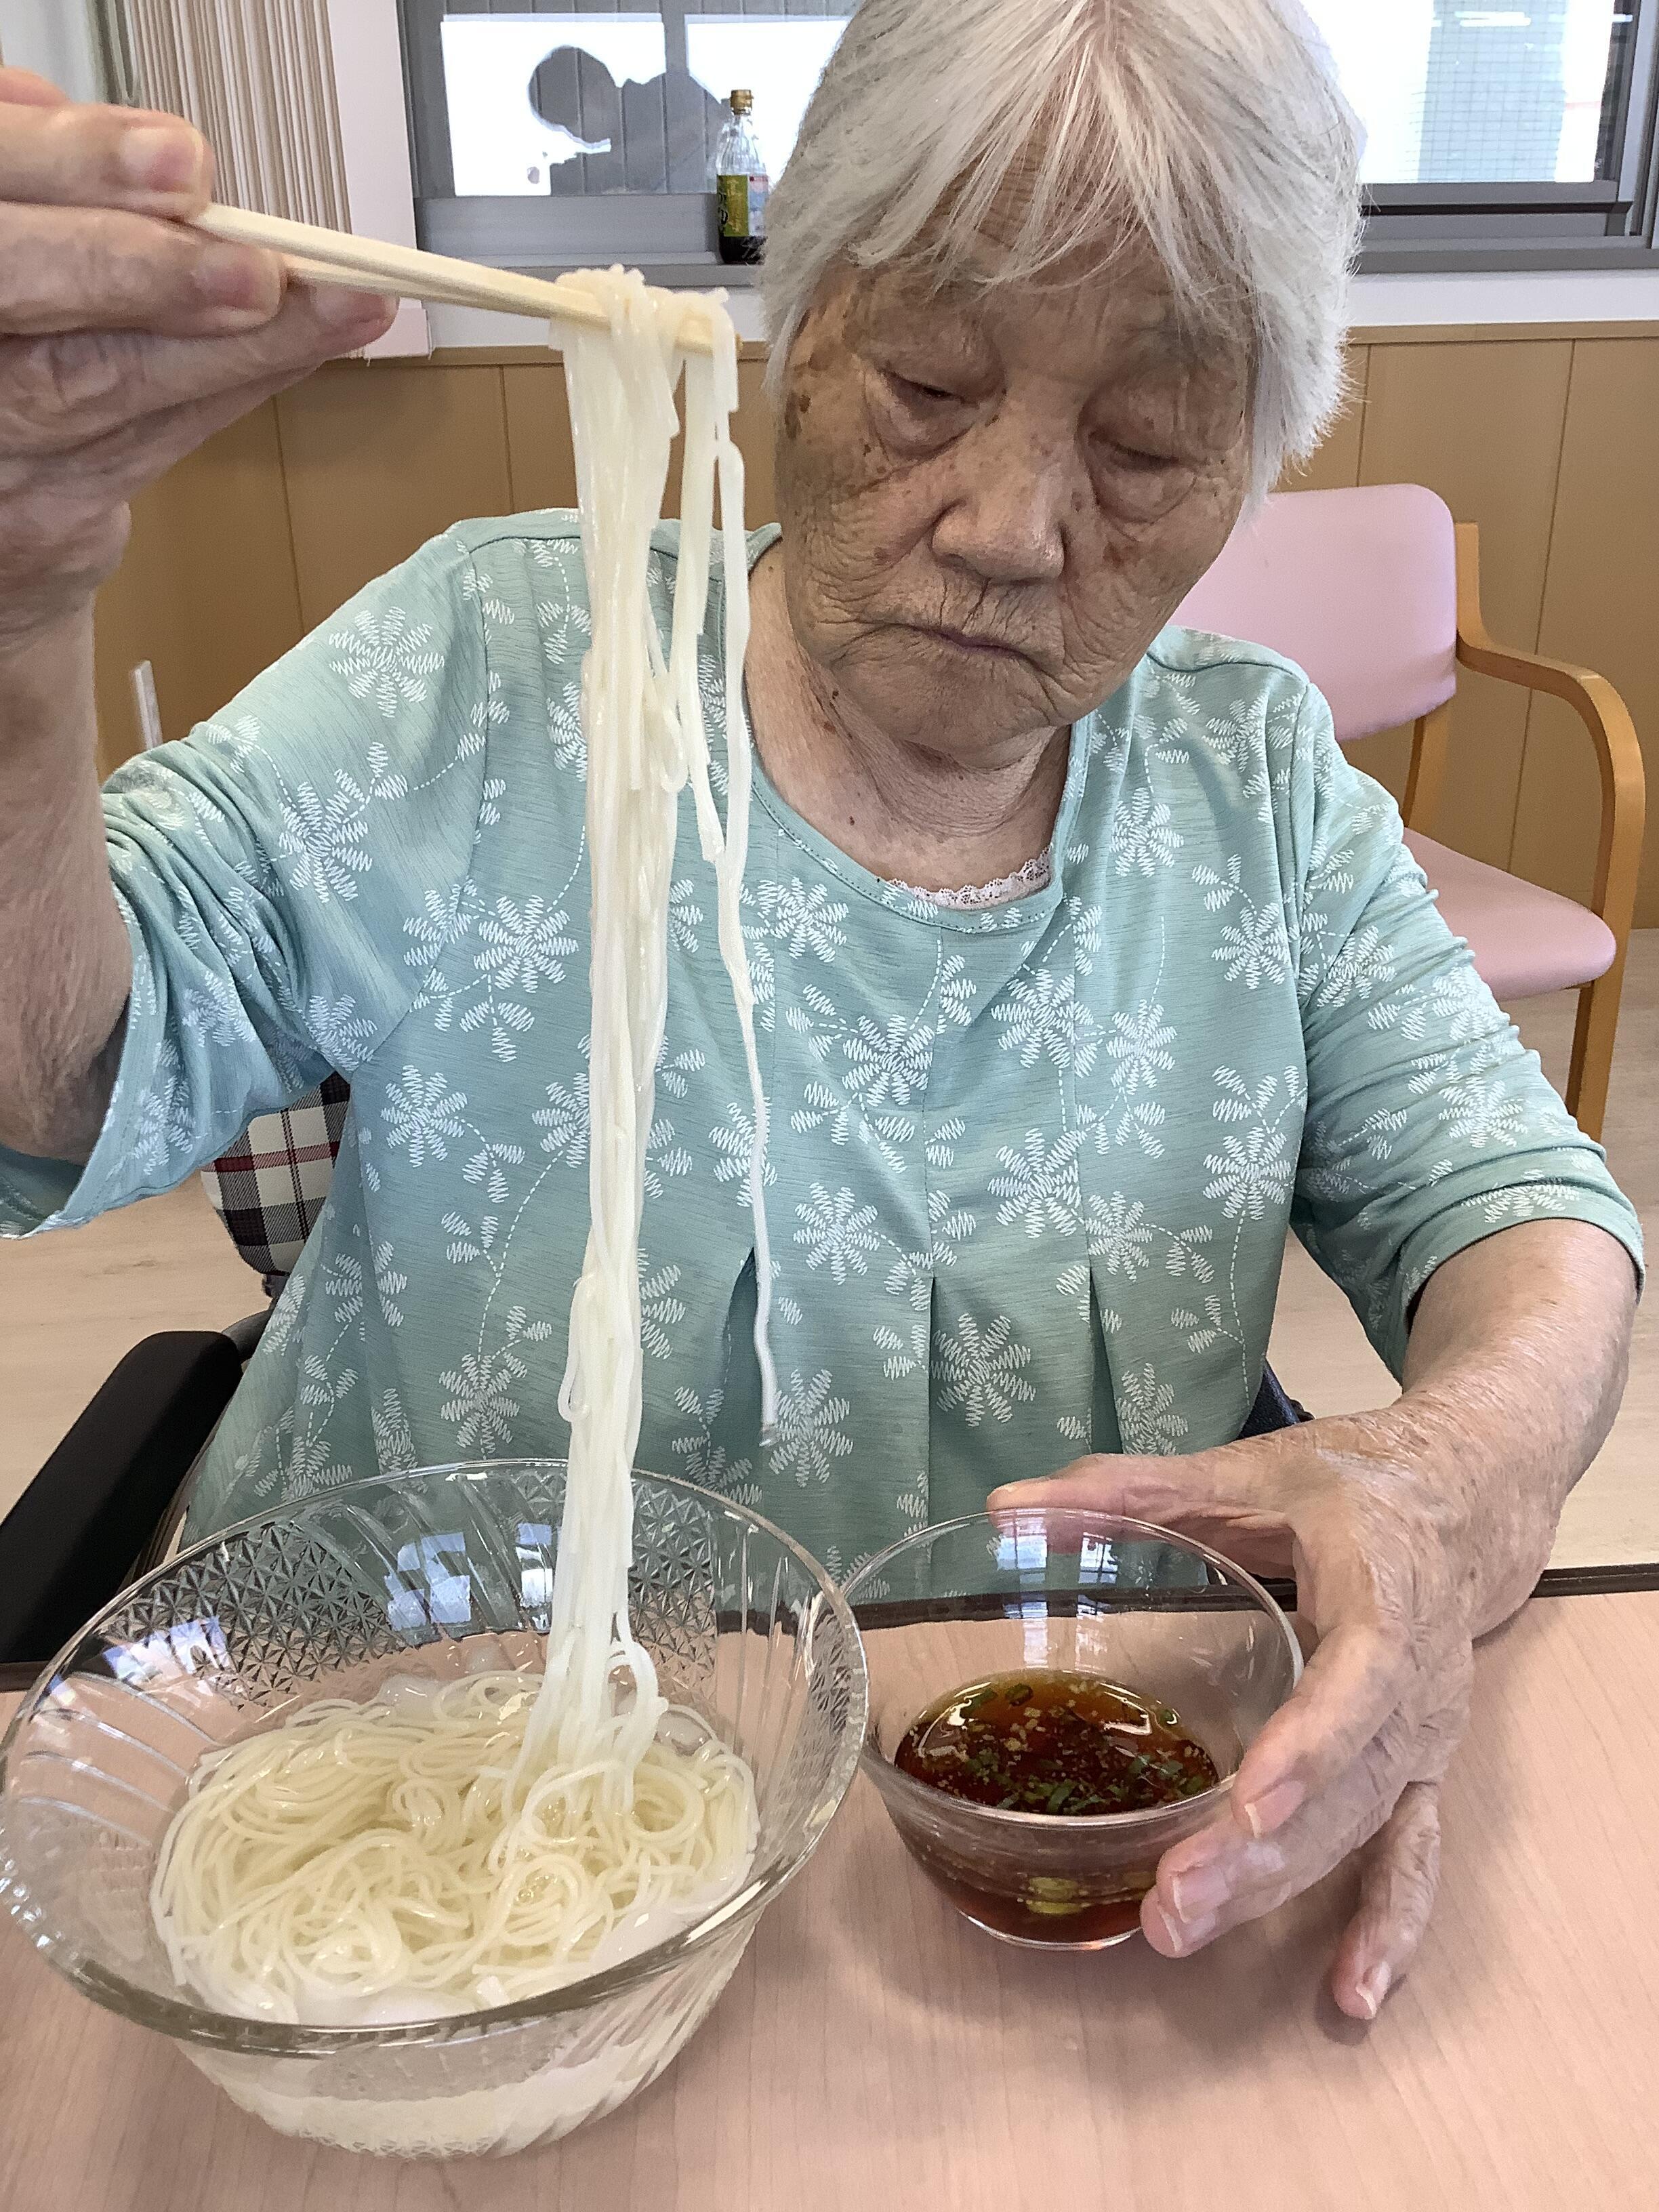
[894,1668,1221,1949]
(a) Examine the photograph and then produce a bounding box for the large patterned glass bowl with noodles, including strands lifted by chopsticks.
[0,272,863,2154]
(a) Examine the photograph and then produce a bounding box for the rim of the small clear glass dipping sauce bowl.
[843,1504,1303,1845]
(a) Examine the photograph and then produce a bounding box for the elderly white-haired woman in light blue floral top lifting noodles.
[0,0,1637,2018]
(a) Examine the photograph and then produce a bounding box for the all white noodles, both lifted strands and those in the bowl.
[152,270,777,2022]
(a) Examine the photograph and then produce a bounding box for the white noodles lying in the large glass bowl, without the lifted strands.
[152,1673,756,2026]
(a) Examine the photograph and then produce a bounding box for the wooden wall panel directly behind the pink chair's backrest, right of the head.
[1360,341,1573,867]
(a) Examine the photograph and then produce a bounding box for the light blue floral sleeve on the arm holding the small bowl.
[1285,690,1641,1376]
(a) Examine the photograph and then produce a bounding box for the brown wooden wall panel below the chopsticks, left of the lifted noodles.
[276,363,513,630]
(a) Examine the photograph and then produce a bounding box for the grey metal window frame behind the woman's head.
[398,0,1659,285]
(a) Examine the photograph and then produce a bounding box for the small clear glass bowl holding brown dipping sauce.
[843,1507,1303,1951]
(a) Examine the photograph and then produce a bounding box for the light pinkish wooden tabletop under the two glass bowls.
[0,1593,1659,2212]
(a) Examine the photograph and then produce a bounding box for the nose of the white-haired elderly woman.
[933,422,1082,584]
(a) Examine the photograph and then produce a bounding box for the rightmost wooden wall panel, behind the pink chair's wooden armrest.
[1515,338,1659,929]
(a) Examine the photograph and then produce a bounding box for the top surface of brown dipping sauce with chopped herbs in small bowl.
[894,1668,1221,1818]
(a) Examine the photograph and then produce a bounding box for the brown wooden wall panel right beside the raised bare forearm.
[98,403,303,774]
